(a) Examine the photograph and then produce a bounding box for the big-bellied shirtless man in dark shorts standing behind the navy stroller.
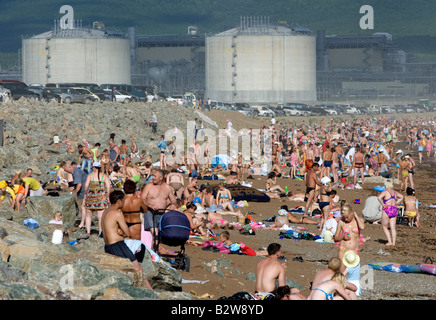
[141,169,177,249]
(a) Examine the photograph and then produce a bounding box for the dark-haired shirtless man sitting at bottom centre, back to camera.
[255,243,286,299]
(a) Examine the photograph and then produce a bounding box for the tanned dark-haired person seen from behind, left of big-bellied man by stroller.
[121,180,148,240]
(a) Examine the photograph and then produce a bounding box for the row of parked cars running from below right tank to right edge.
[213,102,435,117]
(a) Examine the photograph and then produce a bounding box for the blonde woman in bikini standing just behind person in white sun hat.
[334,203,365,272]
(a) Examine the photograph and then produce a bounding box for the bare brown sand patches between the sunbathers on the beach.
[174,128,436,300]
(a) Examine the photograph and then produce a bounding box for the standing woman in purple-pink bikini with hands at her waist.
[378,179,403,246]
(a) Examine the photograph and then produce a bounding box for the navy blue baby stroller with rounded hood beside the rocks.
[154,210,191,272]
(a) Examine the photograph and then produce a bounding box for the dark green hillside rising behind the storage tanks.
[0,0,436,54]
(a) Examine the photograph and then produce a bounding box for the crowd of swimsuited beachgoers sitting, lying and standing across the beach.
[0,112,436,300]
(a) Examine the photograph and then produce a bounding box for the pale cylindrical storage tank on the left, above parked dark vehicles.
[22,29,131,85]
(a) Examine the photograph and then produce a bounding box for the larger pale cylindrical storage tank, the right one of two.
[206,26,316,103]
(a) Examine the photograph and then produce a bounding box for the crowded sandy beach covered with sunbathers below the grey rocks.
[0,99,436,300]
